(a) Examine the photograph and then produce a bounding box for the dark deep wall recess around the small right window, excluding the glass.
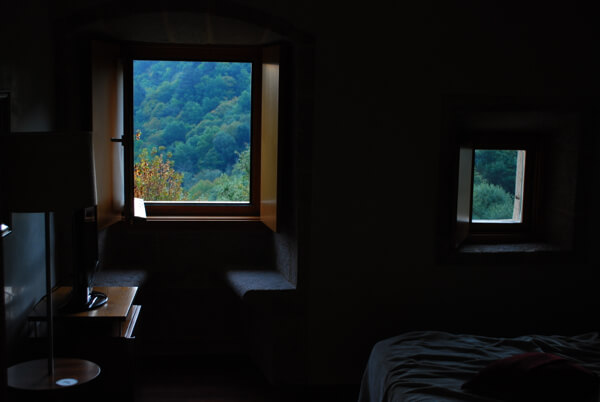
[436,93,597,265]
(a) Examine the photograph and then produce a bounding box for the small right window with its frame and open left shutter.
[456,137,541,246]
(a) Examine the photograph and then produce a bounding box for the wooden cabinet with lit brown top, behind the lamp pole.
[15,286,141,402]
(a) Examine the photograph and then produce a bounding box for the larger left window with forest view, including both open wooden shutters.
[91,41,290,231]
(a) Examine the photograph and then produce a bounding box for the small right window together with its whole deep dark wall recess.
[446,96,587,259]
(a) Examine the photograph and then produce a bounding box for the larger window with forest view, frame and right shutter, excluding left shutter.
[115,44,280,230]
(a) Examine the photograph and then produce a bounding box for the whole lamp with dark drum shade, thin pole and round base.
[0,132,100,390]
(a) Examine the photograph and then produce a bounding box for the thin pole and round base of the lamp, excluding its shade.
[7,212,100,390]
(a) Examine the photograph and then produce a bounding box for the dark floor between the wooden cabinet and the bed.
[135,356,358,402]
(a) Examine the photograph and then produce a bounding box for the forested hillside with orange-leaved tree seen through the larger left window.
[133,60,252,203]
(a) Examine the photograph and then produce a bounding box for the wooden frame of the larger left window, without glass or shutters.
[122,43,262,219]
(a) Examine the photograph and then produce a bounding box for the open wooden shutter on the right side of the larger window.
[260,47,279,231]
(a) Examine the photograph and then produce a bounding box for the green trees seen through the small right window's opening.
[471,149,525,222]
